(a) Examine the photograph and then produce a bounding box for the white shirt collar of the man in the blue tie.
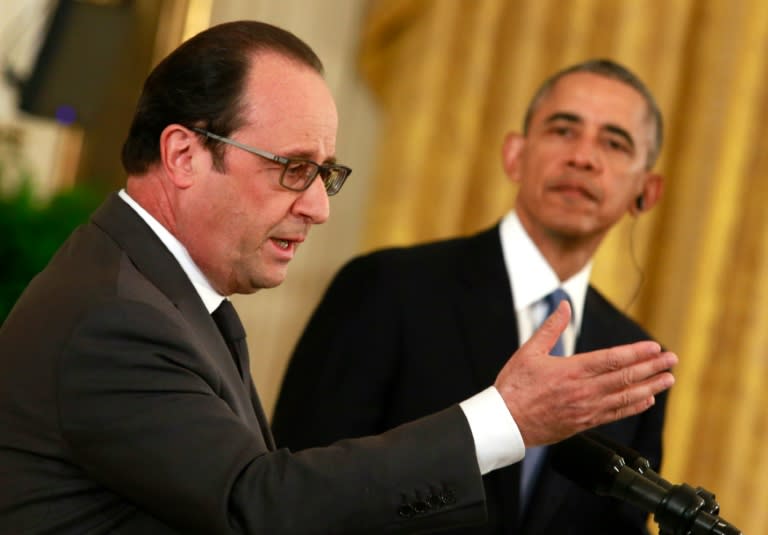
[499,211,592,332]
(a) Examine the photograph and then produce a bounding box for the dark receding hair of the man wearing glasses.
[122,20,323,174]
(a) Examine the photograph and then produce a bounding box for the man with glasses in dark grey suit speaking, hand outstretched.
[0,21,676,534]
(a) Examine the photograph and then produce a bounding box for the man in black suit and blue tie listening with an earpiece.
[273,60,666,535]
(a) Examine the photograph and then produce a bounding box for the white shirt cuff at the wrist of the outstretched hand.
[459,386,525,475]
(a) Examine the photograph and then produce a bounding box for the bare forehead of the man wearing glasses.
[242,52,338,156]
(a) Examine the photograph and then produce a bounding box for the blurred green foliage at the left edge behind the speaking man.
[0,180,101,324]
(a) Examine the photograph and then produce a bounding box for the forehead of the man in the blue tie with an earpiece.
[531,72,650,138]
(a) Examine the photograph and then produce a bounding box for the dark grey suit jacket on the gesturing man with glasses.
[0,196,485,535]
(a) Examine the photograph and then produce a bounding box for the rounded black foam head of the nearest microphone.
[549,434,625,495]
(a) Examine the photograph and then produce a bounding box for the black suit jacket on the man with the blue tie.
[272,227,666,535]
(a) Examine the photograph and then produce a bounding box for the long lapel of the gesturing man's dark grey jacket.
[92,194,274,448]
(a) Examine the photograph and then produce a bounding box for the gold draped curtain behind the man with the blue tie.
[361,0,768,533]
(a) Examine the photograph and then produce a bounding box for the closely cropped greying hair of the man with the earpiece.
[523,59,664,169]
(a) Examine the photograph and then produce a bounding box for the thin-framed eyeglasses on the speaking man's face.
[192,127,352,197]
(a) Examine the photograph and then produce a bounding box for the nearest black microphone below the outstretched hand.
[549,435,741,535]
